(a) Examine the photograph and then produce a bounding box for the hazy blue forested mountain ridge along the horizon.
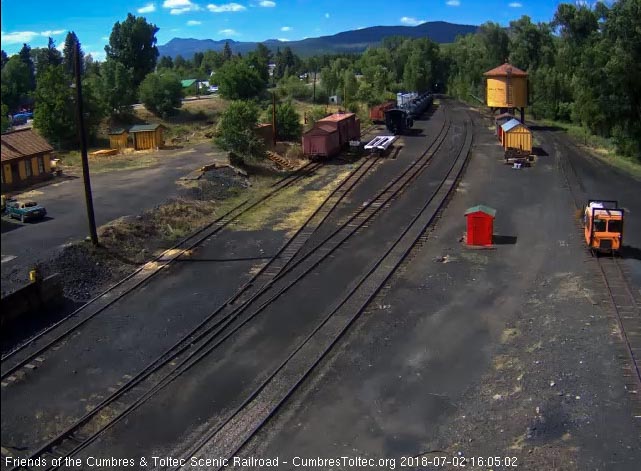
[158,21,478,58]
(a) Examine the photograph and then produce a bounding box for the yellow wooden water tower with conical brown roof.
[483,62,528,122]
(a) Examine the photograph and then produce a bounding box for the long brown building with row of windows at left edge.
[1,129,53,193]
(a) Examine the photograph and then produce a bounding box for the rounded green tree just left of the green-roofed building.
[140,73,182,117]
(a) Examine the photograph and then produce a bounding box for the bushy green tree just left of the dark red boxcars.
[214,101,265,159]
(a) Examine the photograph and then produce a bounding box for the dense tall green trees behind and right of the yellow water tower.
[446,0,641,161]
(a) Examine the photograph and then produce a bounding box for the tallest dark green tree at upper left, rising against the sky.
[105,13,158,87]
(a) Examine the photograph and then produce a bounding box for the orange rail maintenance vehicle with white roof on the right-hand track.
[583,200,624,253]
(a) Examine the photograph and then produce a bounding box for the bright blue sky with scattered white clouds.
[1,0,560,60]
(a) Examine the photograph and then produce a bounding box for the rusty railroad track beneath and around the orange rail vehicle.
[555,132,641,406]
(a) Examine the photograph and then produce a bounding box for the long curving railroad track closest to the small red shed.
[178,104,473,470]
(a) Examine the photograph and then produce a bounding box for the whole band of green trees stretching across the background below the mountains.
[1,0,641,160]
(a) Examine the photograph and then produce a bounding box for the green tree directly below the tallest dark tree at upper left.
[97,59,136,115]
